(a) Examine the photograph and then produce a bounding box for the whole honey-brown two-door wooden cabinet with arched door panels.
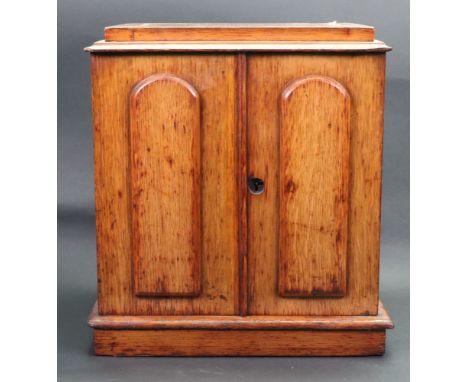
[87,24,392,355]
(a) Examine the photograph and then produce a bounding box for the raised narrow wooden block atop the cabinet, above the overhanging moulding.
[104,22,374,41]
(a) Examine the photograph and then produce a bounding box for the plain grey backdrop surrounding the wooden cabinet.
[58,0,409,381]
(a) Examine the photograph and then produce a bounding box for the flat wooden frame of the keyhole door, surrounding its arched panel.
[247,54,385,315]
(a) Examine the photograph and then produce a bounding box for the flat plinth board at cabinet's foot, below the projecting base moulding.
[94,329,385,356]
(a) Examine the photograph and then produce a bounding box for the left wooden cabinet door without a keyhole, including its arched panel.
[92,54,239,315]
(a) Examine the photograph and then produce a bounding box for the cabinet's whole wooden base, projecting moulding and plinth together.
[89,304,393,356]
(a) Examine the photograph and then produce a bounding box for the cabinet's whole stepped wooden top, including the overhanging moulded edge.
[86,22,389,52]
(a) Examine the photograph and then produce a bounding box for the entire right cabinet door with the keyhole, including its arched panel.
[247,54,384,315]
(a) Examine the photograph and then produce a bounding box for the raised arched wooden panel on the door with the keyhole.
[278,75,350,297]
